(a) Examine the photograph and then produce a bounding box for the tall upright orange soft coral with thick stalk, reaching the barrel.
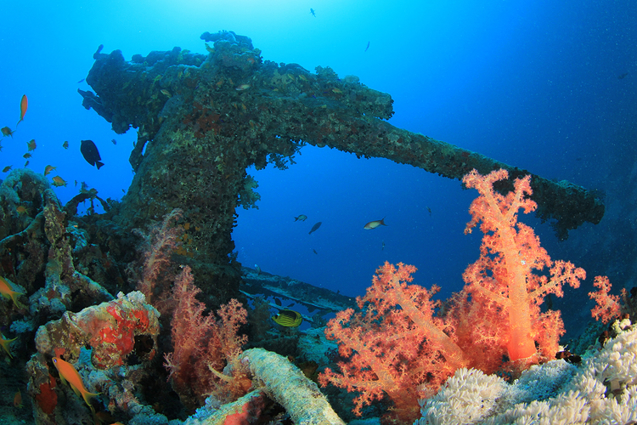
[462,170,586,362]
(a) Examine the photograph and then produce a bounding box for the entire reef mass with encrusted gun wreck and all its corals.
[0,31,620,425]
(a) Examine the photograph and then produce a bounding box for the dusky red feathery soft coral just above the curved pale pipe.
[165,267,249,408]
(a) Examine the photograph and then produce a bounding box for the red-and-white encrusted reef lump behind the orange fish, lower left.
[27,292,159,423]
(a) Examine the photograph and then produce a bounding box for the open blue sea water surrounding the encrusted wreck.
[0,0,637,336]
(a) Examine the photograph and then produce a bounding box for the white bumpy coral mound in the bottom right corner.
[416,328,637,425]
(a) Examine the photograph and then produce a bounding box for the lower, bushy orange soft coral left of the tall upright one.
[319,263,469,421]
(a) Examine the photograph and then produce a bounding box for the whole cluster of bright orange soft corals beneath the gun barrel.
[319,170,610,423]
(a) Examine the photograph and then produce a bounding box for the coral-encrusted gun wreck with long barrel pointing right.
[79,31,604,308]
